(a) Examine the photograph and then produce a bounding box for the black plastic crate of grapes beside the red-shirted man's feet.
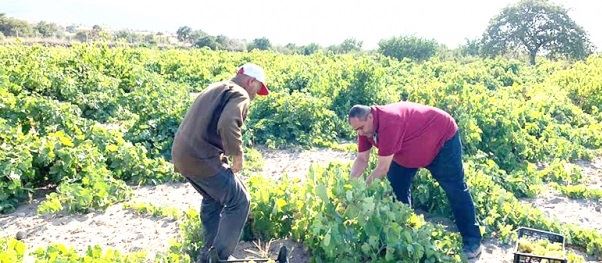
[514,227,568,263]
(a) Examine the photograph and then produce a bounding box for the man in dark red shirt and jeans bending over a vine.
[349,102,481,259]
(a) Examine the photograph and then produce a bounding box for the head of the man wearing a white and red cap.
[234,63,270,99]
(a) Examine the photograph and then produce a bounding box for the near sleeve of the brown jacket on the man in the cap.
[217,94,250,156]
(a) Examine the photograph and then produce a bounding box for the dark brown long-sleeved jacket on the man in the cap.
[171,81,251,177]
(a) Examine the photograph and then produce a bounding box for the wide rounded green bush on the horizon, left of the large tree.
[378,36,439,61]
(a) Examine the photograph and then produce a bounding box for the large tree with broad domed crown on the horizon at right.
[482,0,593,65]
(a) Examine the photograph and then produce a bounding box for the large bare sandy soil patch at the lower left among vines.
[0,200,178,258]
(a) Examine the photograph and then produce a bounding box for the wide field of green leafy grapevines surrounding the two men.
[0,44,602,262]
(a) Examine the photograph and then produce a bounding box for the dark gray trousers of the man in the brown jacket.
[186,169,250,259]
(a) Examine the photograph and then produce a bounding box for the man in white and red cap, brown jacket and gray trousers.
[172,63,269,262]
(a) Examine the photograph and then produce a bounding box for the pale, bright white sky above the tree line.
[0,0,602,51]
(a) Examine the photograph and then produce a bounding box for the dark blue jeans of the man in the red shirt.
[387,132,481,246]
